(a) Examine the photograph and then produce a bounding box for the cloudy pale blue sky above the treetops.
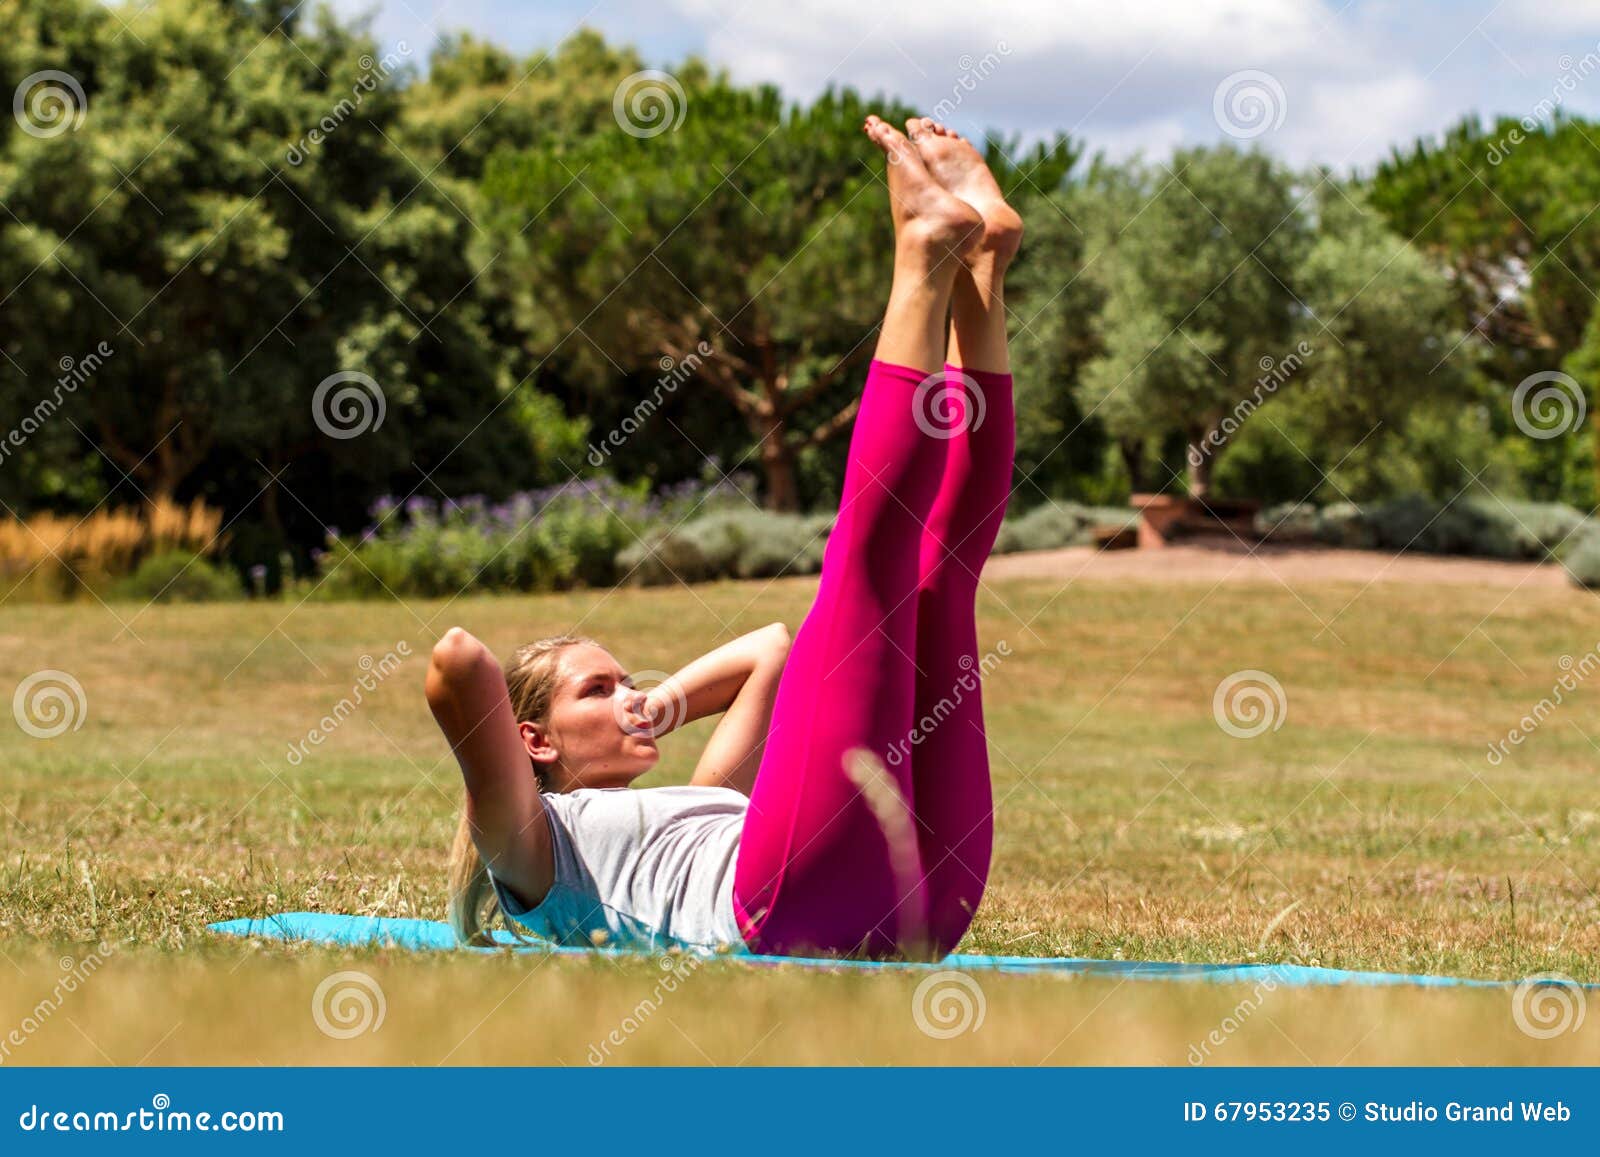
[331,0,1600,171]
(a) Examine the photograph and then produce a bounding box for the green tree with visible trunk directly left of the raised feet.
[485,61,1068,510]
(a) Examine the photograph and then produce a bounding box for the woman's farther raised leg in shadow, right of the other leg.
[907,118,1022,954]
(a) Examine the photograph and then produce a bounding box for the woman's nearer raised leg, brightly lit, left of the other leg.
[733,117,982,955]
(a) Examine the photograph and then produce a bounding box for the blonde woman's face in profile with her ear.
[522,643,661,791]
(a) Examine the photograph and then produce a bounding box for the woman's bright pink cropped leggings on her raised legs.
[733,362,1016,957]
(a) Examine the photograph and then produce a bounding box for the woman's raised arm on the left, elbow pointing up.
[427,627,555,907]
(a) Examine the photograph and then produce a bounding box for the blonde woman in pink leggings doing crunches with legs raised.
[427,117,1022,957]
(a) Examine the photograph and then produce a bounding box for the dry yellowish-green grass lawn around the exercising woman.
[0,579,1600,1064]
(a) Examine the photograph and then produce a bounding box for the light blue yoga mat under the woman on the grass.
[208,912,1568,987]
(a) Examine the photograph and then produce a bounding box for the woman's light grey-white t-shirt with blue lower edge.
[490,786,750,952]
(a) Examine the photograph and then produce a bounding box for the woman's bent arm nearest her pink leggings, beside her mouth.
[645,623,789,795]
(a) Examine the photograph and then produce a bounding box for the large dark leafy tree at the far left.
[0,0,582,556]
